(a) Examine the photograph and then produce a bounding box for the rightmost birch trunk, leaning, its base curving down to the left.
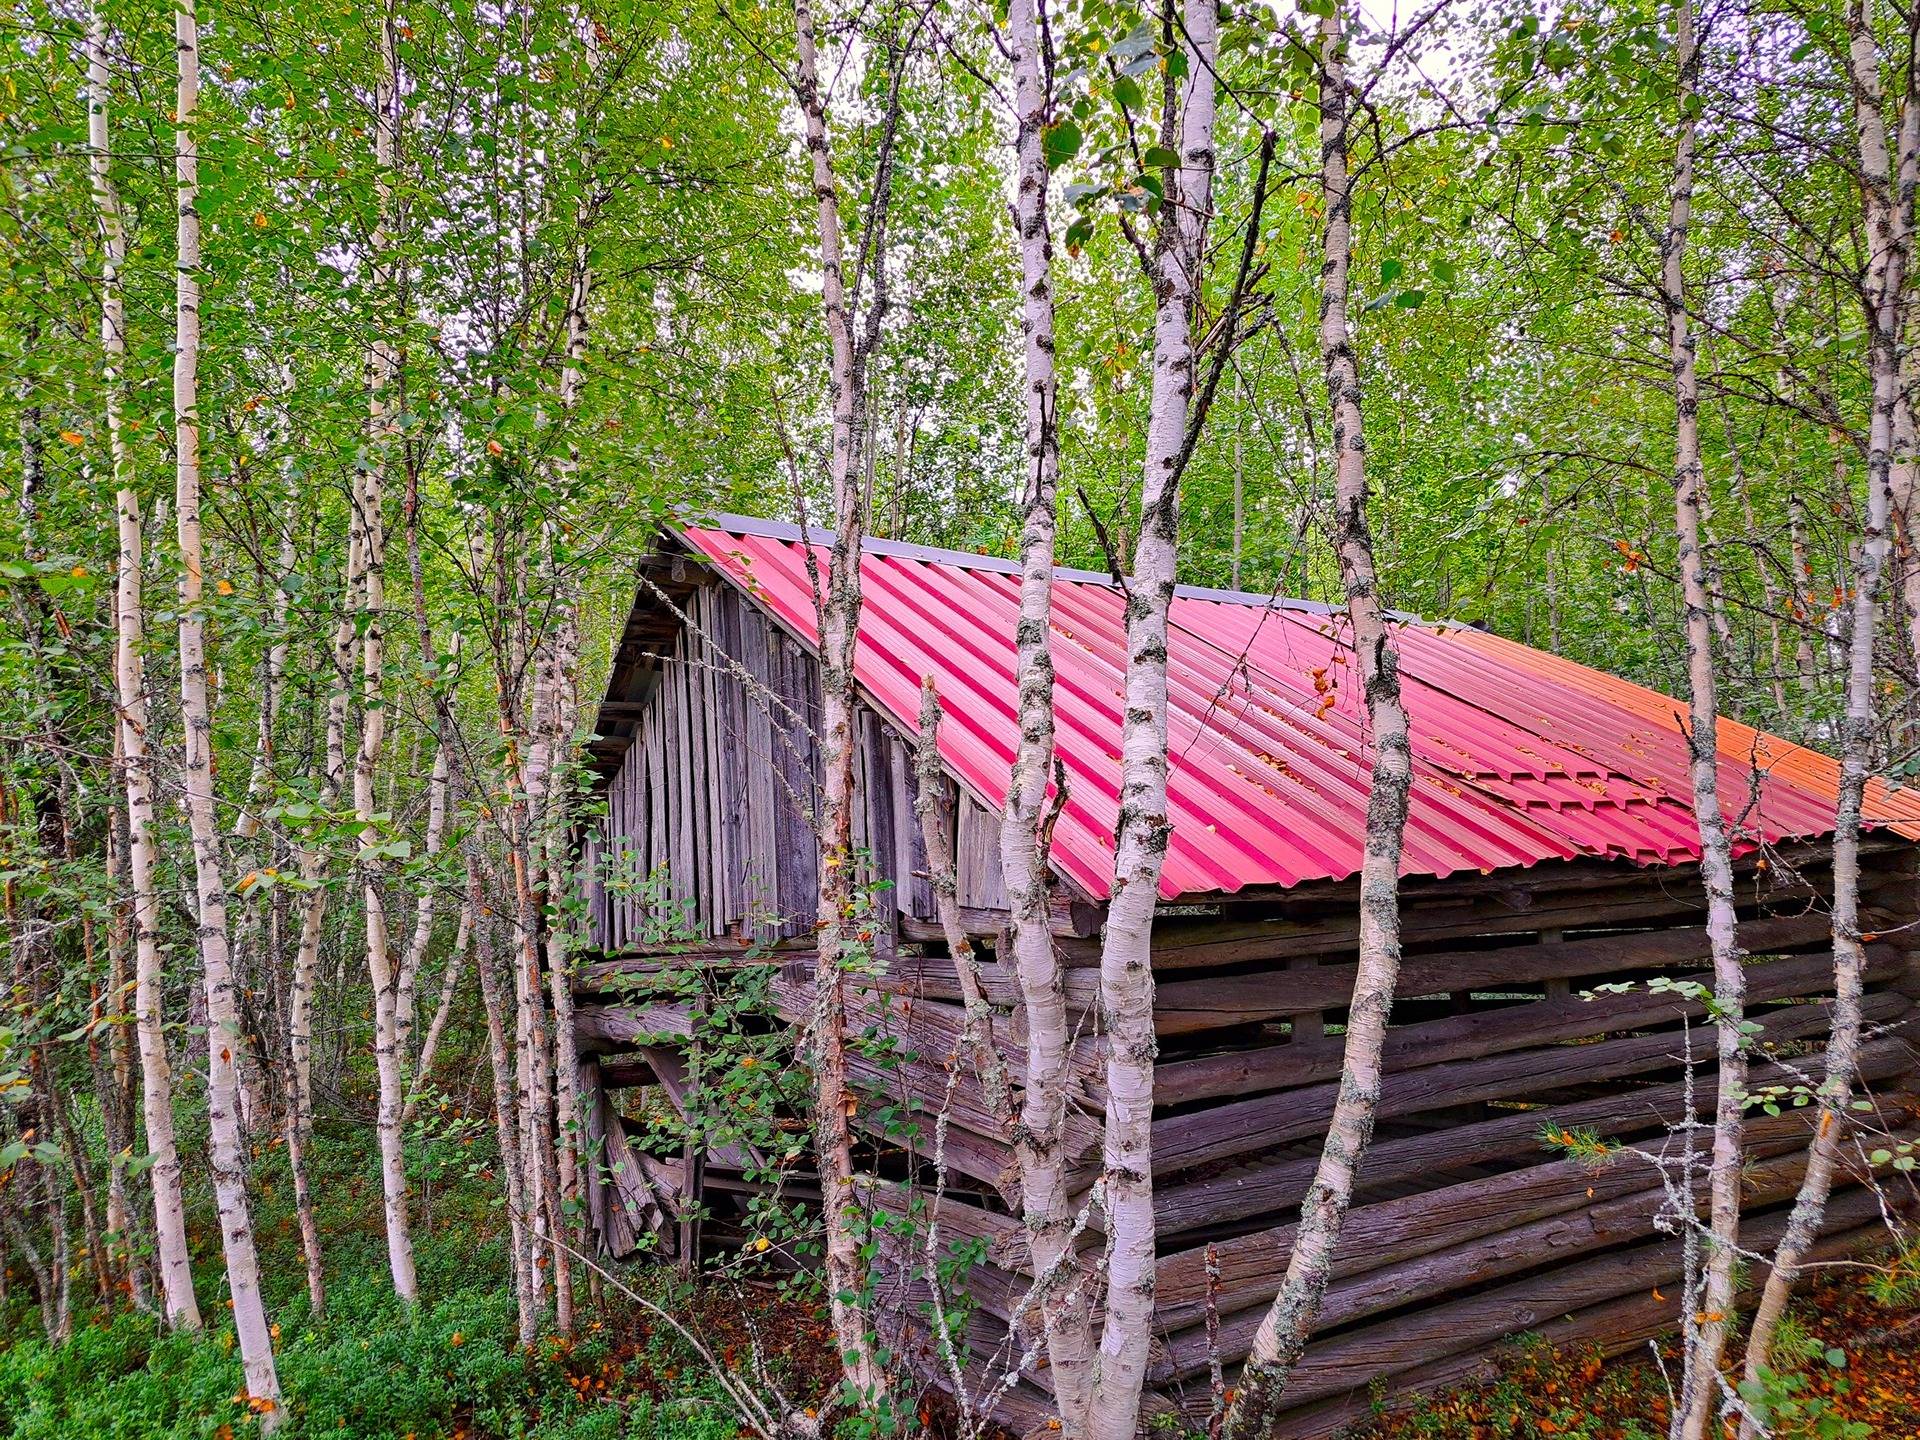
[1740,0,1920,1436]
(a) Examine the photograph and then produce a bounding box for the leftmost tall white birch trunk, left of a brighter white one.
[86,6,200,1331]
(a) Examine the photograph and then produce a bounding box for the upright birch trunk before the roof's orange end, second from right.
[1661,0,1747,1440]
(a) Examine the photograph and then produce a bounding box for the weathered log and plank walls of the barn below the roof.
[578,568,1920,1436]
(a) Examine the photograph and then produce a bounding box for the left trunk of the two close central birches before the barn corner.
[998,0,1092,1440]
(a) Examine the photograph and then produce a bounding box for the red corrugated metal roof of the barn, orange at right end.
[664,516,1920,900]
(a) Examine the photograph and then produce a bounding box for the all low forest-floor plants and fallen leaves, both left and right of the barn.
[0,1110,1920,1440]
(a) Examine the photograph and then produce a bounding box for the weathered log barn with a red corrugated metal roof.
[578,516,1920,1436]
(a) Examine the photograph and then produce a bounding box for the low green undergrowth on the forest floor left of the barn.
[0,1121,808,1440]
